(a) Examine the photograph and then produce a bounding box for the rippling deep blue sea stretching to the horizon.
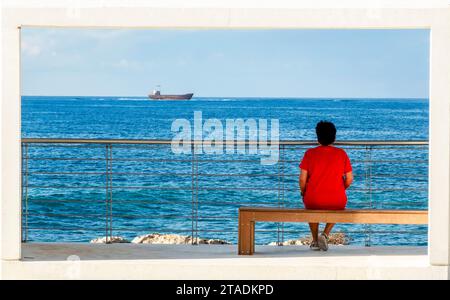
[22,96,429,245]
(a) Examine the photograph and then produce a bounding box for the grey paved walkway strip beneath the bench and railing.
[22,243,427,264]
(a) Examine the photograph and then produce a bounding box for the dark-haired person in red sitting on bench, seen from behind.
[299,121,353,251]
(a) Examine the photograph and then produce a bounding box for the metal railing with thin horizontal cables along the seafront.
[22,138,428,246]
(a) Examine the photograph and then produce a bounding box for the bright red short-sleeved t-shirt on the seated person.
[300,146,352,210]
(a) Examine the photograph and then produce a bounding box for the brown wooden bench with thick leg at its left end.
[238,207,428,255]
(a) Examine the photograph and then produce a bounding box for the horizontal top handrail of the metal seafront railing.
[21,138,429,146]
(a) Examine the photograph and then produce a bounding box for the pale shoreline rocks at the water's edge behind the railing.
[90,232,350,246]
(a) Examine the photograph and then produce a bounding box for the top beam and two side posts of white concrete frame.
[1,7,450,266]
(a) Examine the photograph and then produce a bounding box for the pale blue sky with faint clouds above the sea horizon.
[22,28,429,98]
